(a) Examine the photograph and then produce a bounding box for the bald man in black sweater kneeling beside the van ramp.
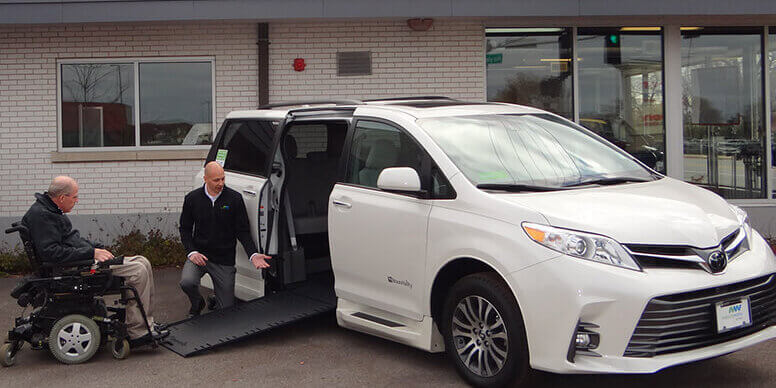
[180,162,270,316]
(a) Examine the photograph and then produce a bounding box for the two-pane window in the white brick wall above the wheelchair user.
[59,58,214,149]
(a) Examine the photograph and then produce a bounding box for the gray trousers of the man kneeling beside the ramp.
[181,260,237,311]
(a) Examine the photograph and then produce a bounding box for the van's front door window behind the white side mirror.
[345,120,425,187]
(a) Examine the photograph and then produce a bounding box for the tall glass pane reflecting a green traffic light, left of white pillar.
[577,27,665,172]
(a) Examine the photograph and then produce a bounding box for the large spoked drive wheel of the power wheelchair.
[48,314,100,364]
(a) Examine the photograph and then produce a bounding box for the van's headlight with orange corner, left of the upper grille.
[523,222,641,271]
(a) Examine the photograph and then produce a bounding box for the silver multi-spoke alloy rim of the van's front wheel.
[451,296,509,377]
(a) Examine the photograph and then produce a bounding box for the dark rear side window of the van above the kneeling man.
[218,120,275,176]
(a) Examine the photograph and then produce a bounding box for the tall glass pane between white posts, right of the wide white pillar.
[682,27,767,198]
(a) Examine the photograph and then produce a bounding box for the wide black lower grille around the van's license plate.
[624,274,776,357]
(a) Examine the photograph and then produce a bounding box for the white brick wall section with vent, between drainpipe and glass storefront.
[269,20,485,102]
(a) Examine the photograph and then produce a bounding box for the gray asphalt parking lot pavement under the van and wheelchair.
[0,268,776,388]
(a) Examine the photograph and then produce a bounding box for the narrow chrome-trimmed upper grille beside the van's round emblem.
[625,227,749,272]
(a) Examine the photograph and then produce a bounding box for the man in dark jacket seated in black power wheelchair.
[0,176,169,366]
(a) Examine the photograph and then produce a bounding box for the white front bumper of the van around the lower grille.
[508,230,776,373]
